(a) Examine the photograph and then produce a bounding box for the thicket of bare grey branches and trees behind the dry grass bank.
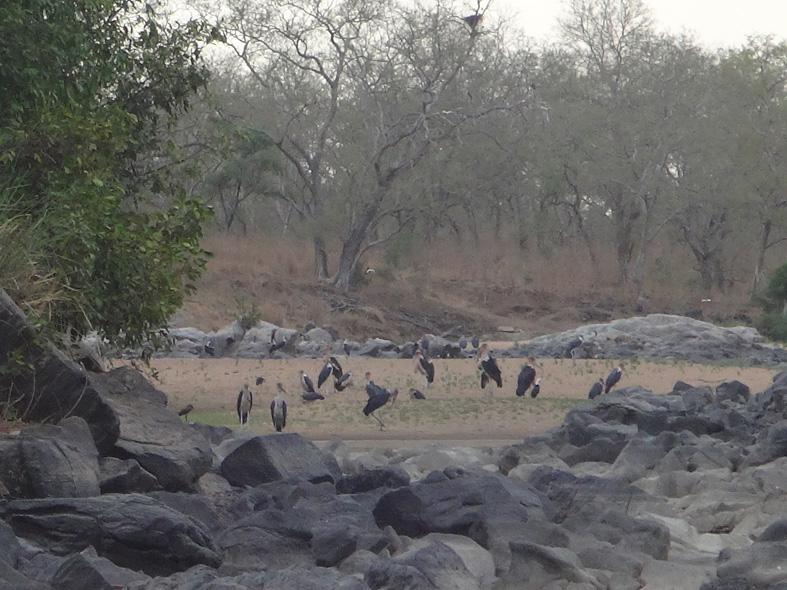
[186,0,787,291]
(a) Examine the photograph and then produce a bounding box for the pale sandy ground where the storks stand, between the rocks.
[124,357,778,447]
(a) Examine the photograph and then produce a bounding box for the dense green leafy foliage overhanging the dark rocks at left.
[0,0,222,352]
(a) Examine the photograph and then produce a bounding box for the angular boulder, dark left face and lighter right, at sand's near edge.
[221,433,341,486]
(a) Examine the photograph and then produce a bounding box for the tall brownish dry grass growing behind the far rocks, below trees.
[186,229,760,331]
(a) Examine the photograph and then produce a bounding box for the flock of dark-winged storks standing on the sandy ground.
[197,336,623,432]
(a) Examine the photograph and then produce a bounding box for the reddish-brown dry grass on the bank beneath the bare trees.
[180,235,756,339]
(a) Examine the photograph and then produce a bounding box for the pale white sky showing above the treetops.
[496,0,787,48]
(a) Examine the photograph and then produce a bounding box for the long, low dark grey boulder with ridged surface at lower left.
[0,494,221,576]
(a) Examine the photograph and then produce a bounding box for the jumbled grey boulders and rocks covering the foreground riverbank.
[0,292,787,590]
